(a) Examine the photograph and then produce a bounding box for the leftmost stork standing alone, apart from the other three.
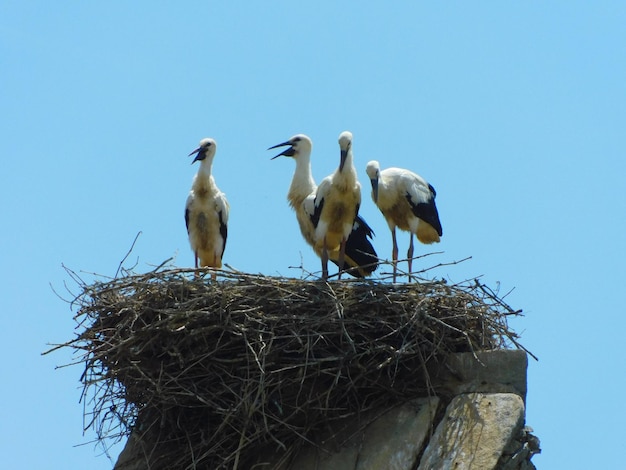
[185,139,230,279]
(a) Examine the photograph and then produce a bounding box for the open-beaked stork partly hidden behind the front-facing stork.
[268,134,378,277]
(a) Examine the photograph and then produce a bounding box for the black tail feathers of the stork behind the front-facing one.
[332,216,378,277]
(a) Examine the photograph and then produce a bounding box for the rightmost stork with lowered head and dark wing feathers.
[366,160,443,282]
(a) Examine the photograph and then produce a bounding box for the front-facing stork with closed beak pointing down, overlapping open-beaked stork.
[312,131,361,279]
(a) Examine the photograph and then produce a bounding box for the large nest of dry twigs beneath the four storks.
[55,268,521,469]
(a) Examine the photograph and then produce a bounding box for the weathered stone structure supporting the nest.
[115,350,540,470]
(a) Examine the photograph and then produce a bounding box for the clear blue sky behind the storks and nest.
[0,0,626,470]
